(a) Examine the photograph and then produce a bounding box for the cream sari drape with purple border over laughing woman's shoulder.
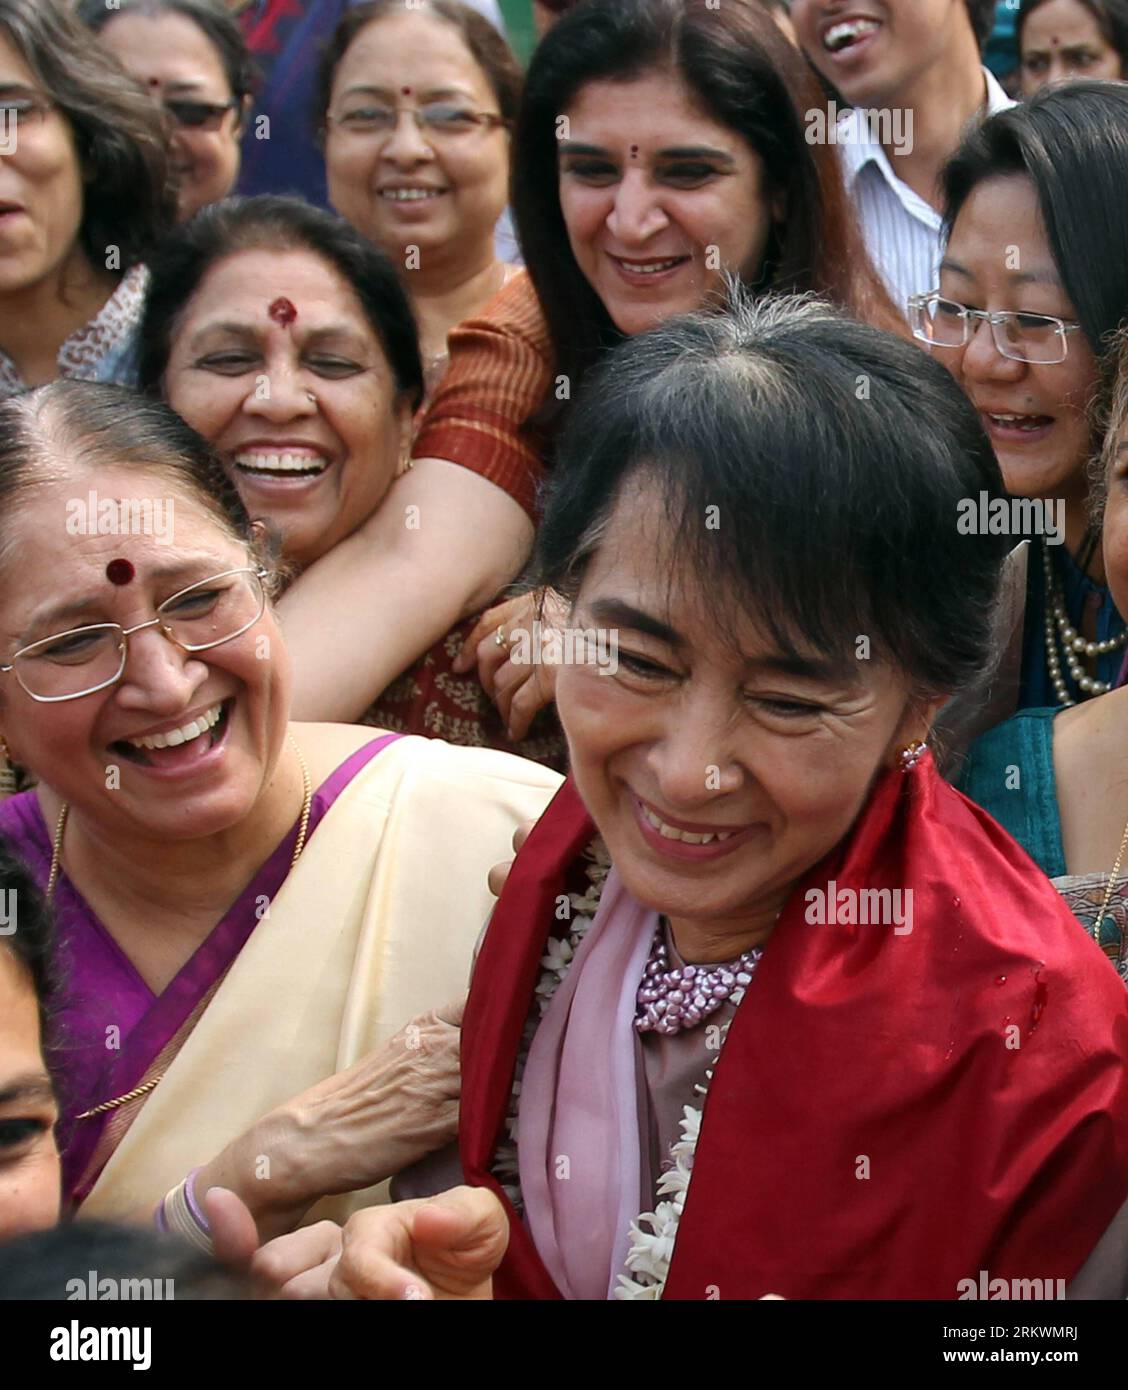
[0,735,560,1220]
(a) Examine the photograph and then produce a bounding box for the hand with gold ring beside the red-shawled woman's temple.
[454,589,568,741]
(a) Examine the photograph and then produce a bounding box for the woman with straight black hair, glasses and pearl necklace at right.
[910,82,1128,728]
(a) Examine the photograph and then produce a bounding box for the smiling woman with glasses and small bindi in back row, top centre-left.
[318,0,521,391]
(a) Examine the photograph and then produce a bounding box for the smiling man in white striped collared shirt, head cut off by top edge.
[792,0,1013,313]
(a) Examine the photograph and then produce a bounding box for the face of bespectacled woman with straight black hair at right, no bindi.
[932,174,1097,514]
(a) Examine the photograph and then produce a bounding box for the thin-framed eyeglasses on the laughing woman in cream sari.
[0,566,267,705]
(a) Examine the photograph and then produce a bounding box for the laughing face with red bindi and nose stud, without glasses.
[163,250,411,567]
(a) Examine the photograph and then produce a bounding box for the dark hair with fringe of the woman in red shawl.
[533,286,1010,695]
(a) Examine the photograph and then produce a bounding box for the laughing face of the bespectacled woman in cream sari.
[0,463,290,842]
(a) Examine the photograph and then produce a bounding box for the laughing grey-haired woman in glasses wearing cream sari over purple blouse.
[0,382,558,1236]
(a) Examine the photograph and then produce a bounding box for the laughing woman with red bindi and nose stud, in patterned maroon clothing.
[140,195,563,766]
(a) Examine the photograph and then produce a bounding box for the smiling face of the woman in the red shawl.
[556,485,917,959]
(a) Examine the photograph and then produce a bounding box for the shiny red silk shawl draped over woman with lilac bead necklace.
[460,756,1128,1298]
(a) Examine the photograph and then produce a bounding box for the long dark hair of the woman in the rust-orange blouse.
[513,0,900,414]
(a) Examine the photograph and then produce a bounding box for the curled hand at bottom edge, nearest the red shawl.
[329,1187,508,1300]
